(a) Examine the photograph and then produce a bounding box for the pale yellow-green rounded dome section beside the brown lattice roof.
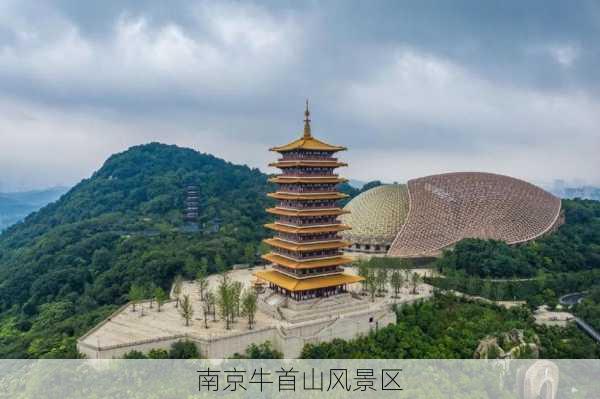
[341,184,408,247]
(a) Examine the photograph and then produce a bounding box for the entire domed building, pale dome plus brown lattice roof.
[342,172,563,258]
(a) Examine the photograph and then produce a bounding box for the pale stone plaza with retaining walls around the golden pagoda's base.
[77,267,432,359]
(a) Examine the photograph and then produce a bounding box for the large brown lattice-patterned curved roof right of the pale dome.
[386,172,561,257]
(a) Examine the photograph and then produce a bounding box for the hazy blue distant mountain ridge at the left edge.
[0,187,68,231]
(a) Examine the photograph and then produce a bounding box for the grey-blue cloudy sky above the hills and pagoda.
[0,0,600,191]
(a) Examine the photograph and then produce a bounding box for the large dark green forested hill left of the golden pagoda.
[0,143,268,358]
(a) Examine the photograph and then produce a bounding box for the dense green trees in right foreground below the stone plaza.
[302,294,600,359]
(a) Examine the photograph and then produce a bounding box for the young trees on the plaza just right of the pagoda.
[356,259,422,302]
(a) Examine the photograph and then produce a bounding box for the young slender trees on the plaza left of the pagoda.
[128,271,258,330]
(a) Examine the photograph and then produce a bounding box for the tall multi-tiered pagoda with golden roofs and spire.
[256,101,363,300]
